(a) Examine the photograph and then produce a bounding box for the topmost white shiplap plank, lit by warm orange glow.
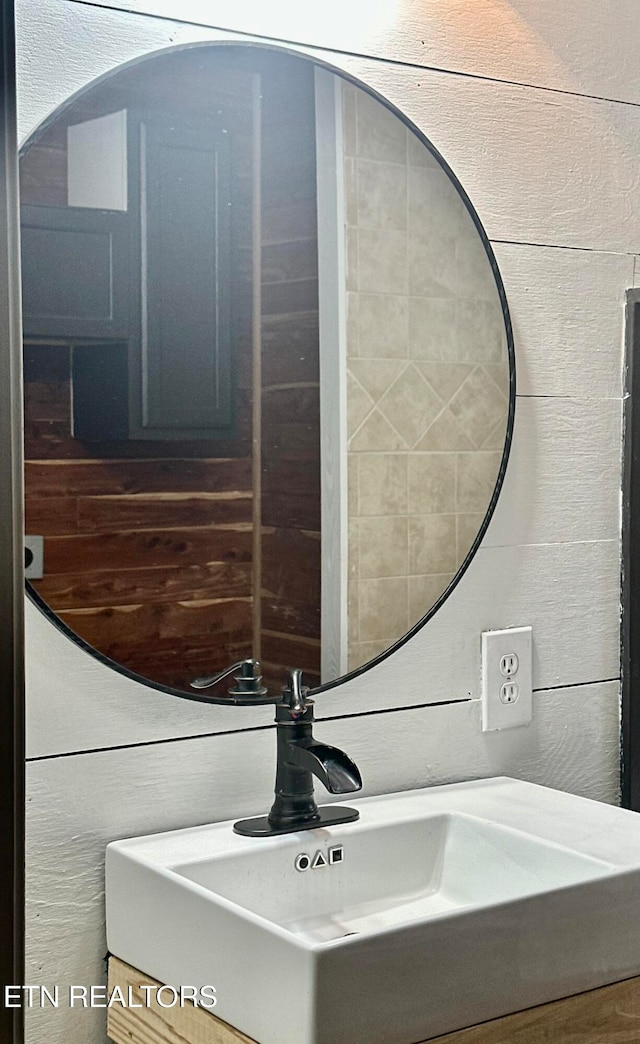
[60,0,640,103]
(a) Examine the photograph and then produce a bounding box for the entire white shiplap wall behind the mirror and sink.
[18,0,640,1044]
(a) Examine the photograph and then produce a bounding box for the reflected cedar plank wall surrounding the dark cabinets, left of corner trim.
[21,55,257,689]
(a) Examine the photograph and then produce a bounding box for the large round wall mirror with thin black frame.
[20,44,515,695]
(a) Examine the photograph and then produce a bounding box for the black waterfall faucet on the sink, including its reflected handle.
[191,660,362,837]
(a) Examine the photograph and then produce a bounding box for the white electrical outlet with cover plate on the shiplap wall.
[482,627,532,732]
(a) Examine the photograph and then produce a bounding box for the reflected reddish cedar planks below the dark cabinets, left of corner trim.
[25,345,252,687]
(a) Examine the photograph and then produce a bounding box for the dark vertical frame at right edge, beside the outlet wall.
[620,289,640,811]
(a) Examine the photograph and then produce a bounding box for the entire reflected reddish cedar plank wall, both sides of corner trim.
[21,56,321,689]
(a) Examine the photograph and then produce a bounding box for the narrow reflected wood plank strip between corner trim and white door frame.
[261,59,321,689]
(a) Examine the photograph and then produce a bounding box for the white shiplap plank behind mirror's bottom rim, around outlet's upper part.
[27,540,619,756]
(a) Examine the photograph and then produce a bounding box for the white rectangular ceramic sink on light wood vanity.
[106,778,640,1044]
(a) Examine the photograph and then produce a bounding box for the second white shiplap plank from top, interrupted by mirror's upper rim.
[19,0,640,253]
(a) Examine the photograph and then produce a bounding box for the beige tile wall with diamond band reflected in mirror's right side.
[342,85,508,668]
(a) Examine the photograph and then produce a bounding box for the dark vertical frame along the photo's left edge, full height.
[0,0,24,1044]
